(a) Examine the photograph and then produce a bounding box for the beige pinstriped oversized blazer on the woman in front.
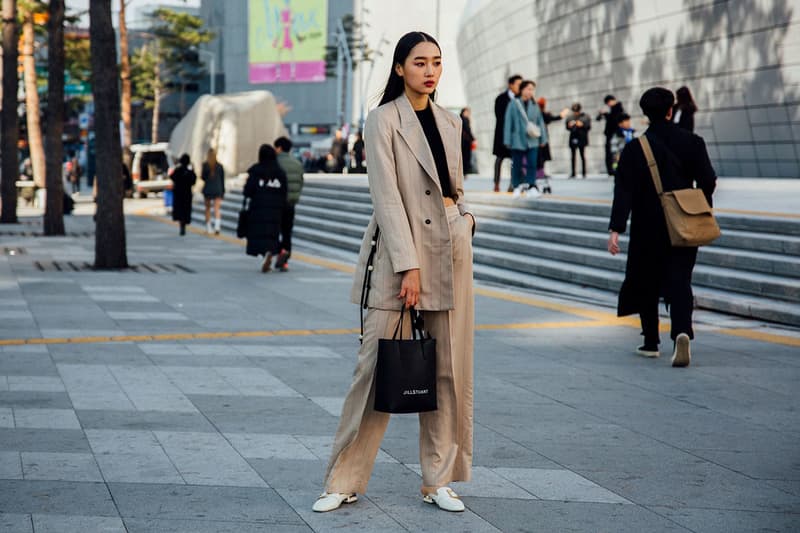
[350,94,471,311]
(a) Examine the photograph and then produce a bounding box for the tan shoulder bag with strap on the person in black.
[639,135,722,247]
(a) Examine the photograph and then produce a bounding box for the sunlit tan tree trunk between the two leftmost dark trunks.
[22,11,45,188]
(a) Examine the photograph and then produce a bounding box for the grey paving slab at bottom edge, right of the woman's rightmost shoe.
[464,497,690,533]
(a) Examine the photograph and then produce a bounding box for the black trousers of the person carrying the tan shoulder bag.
[639,248,697,344]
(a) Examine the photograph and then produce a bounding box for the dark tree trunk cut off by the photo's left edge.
[0,0,19,224]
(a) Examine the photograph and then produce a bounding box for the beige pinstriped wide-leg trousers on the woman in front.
[325,206,475,494]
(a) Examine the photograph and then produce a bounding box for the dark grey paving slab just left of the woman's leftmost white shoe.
[109,483,305,526]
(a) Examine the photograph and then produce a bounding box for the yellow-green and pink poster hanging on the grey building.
[248,0,328,83]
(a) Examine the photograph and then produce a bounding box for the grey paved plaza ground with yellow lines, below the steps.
[0,206,800,533]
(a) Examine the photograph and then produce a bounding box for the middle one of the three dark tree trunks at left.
[44,0,64,235]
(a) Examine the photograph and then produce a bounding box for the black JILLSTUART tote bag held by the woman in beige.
[375,307,437,413]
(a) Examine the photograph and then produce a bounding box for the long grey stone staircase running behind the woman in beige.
[193,177,800,326]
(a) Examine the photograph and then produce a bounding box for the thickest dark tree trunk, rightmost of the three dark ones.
[89,0,128,269]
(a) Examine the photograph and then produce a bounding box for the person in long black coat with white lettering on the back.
[244,144,288,272]
